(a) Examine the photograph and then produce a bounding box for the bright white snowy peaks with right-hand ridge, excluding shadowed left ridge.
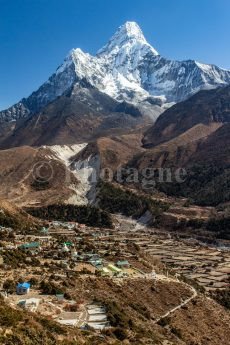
[54,22,230,104]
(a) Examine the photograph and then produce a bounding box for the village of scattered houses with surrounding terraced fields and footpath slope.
[0,200,230,342]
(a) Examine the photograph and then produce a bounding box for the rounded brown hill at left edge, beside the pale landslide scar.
[0,146,79,206]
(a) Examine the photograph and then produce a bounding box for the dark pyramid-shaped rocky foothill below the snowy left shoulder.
[0,84,149,149]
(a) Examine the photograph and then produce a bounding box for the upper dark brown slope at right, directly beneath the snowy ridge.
[143,86,230,147]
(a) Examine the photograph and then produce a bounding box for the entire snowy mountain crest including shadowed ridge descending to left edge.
[0,22,230,121]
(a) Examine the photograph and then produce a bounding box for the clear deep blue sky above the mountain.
[0,0,230,109]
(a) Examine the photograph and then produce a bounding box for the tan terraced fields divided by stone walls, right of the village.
[113,217,230,291]
